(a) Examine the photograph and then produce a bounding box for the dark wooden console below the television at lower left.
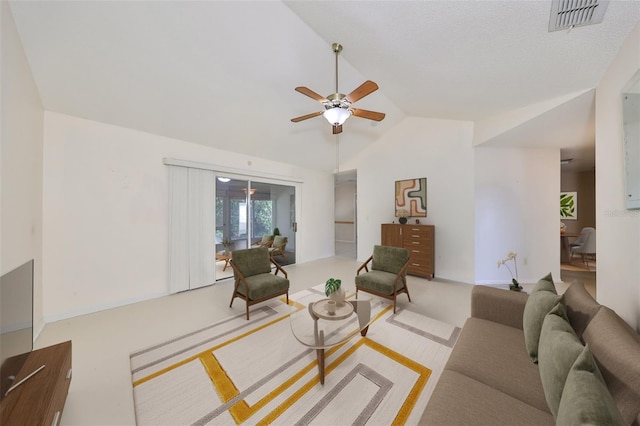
[0,341,71,426]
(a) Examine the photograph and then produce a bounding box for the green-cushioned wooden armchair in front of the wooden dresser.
[355,245,411,314]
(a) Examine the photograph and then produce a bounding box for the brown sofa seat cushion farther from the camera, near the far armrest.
[445,316,549,412]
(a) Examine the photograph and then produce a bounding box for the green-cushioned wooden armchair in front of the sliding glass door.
[229,247,289,320]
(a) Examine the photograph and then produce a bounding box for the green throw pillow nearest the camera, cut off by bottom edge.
[556,345,625,426]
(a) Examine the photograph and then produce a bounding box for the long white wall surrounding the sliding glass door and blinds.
[43,112,333,321]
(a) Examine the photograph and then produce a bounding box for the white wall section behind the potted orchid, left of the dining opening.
[475,146,560,284]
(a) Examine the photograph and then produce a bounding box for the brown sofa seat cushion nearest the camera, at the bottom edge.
[418,370,554,426]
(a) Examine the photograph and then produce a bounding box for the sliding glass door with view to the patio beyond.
[215,175,296,280]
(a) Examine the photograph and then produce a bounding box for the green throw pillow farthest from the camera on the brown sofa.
[522,274,561,363]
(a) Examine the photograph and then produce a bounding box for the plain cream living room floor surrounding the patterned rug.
[35,250,592,426]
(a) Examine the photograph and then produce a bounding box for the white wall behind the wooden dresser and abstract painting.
[350,117,475,283]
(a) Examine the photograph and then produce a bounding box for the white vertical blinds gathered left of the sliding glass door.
[169,166,215,293]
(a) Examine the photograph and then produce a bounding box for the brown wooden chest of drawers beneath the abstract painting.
[382,223,435,280]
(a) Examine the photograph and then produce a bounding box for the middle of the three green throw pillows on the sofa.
[538,298,584,417]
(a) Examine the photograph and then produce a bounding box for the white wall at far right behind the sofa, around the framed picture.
[596,23,640,332]
